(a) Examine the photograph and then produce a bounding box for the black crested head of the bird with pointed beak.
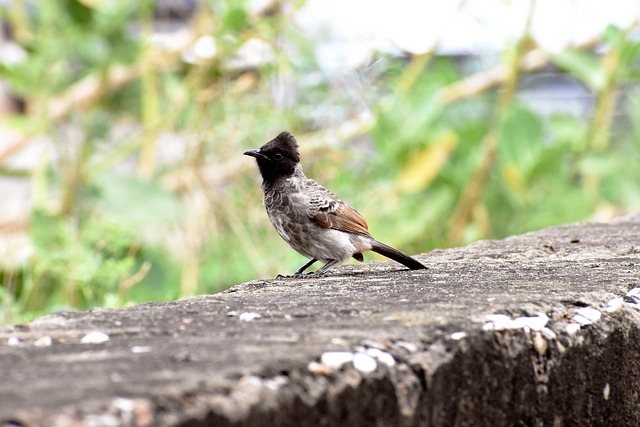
[243,132,300,182]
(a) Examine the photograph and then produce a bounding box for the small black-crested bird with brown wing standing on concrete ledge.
[243,131,427,278]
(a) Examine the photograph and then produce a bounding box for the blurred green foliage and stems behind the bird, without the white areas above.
[0,0,640,322]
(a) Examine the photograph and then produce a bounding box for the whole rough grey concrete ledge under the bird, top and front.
[0,215,640,426]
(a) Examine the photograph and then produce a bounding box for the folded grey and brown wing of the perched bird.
[307,180,369,235]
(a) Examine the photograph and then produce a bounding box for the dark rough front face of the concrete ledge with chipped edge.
[15,288,640,426]
